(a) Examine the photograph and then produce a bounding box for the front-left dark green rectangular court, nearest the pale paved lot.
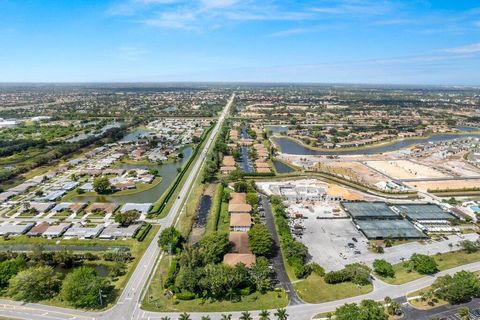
[354,219,426,239]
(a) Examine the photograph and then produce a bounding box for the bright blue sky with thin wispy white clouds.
[0,0,480,85]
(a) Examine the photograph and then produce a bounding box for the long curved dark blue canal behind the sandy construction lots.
[271,133,480,156]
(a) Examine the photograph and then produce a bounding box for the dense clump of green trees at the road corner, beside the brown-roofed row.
[159,228,272,300]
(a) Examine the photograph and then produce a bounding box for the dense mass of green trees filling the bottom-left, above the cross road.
[0,246,128,308]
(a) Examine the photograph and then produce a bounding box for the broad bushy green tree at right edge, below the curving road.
[433,271,480,303]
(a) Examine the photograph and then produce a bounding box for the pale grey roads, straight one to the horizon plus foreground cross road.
[0,95,480,320]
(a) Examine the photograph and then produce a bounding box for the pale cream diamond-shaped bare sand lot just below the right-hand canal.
[367,160,448,179]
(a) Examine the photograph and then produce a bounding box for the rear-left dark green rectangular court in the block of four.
[342,202,400,219]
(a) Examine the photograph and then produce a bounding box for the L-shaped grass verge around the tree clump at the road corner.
[142,256,288,313]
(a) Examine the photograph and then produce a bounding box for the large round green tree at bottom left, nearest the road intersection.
[60,267,113,308]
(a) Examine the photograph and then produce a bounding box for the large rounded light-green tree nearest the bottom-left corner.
[8,266,61,302]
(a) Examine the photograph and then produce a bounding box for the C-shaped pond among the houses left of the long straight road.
[72,147,193,203]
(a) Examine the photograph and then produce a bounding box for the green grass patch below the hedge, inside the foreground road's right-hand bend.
[293,274,373,303]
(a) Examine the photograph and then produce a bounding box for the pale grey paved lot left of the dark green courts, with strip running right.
[299,217,478,271]
